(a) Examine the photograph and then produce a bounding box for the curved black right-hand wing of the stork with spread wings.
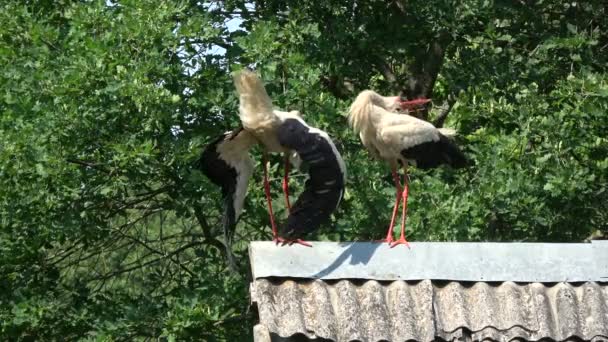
[277,119,345,240]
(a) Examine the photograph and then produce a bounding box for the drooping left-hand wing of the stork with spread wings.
[198,128,257,271]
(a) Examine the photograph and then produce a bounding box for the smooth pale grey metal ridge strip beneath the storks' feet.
[249,241,608,283]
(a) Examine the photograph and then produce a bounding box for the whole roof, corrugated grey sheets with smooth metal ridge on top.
[250,242,608,342]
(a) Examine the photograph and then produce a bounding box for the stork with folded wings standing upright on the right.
[348,90,467,247]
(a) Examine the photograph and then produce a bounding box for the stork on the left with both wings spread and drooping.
[198,71,346,264]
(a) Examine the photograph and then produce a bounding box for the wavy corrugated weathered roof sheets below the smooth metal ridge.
[251,279,608,342]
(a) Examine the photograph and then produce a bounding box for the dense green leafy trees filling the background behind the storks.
[0,0,608,341]
